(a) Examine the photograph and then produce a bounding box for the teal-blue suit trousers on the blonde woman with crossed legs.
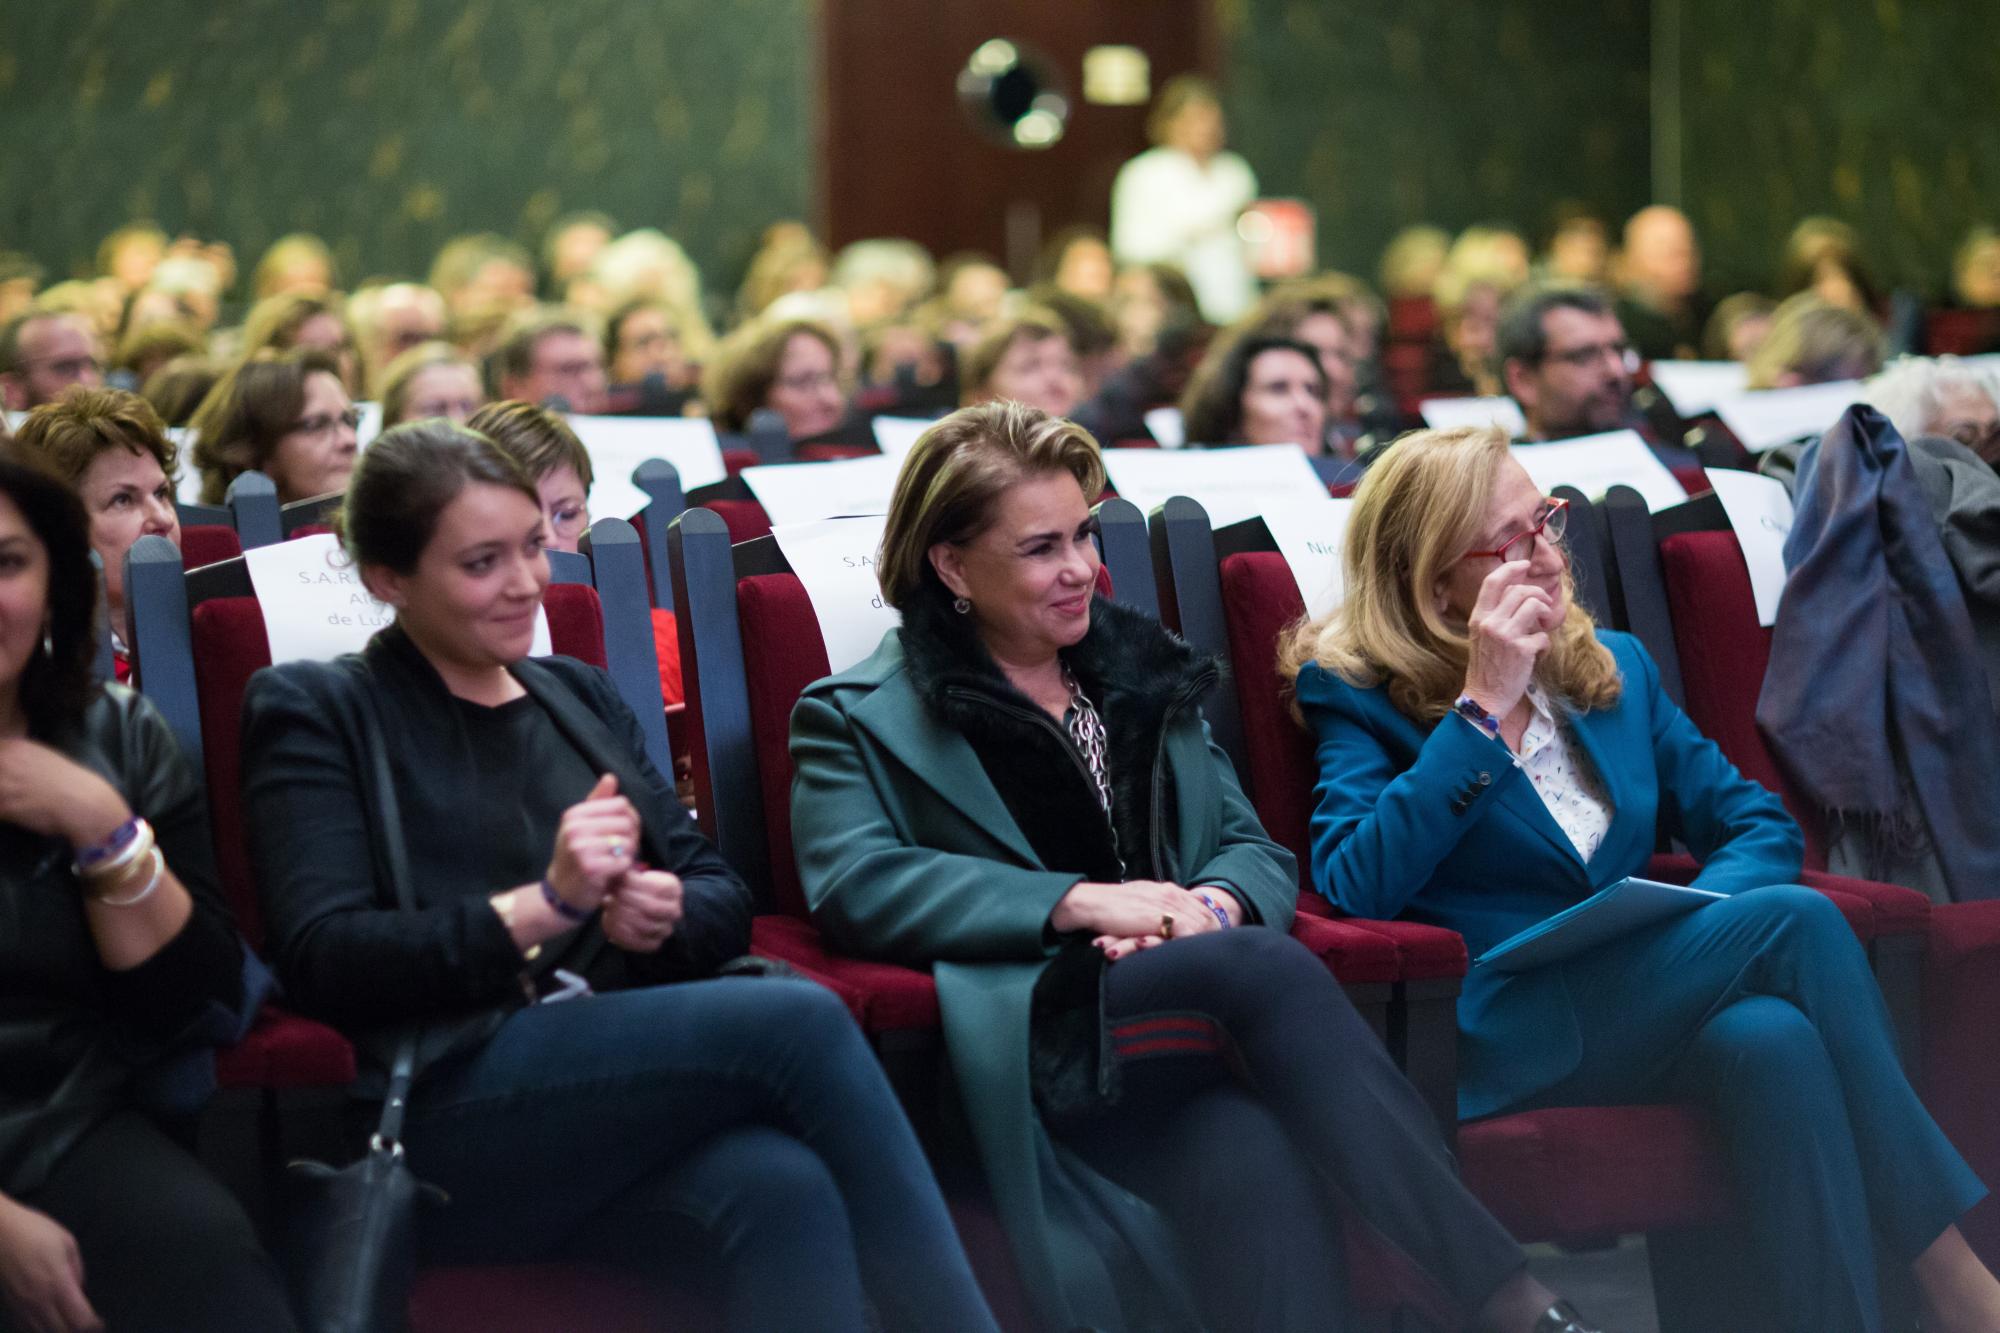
[1510,885,1986,1333]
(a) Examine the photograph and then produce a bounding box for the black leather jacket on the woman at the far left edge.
[0,685,244,1195]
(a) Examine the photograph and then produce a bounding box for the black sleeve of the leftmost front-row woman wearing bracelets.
[104,695,244,1039]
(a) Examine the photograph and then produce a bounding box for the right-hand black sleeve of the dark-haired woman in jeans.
[572,669,752,985]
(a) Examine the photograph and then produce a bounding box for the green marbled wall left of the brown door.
[0,0,812,282]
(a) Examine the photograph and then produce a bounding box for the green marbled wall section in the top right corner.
[1658,0,2000,294]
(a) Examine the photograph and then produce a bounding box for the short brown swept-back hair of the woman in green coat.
[876,402,1104,612]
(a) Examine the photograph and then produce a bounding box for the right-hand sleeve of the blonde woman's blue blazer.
[1620,638,1806,893]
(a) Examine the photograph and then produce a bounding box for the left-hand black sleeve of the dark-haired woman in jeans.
[244,662,522,1025]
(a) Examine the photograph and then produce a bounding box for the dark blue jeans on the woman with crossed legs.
[404,977,996,1333]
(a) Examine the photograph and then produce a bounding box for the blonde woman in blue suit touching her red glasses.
[1280,428,2000,1333]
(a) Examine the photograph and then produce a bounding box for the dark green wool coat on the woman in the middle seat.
[792,598,1298,1329]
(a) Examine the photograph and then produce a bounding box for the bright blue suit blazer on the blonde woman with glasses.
[1298,630,1804,1119]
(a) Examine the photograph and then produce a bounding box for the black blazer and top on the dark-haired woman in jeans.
[244,626,750,1071]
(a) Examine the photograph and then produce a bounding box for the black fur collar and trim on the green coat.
[902,596,1218,1125]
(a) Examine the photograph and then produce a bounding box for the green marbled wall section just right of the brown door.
[1220,0,1650,276]
